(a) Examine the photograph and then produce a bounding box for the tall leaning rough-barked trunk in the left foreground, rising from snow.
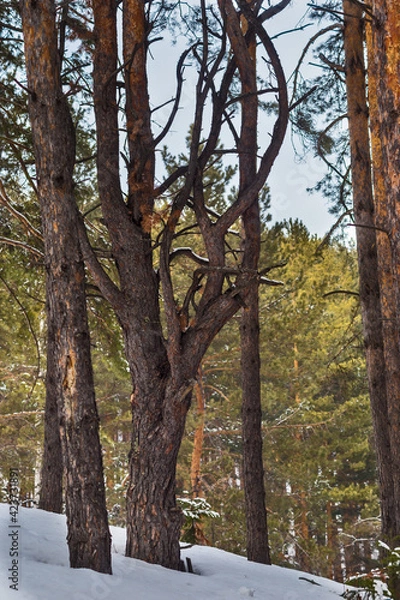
[22,0,111,573]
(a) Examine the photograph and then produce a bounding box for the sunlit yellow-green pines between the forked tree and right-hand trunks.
[179,222,379,578]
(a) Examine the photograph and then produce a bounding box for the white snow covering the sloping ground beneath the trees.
[0,504,360,600]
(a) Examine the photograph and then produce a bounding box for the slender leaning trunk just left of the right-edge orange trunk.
[343,0,396,538]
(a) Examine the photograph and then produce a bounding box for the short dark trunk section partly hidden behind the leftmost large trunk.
[39,312,64,513]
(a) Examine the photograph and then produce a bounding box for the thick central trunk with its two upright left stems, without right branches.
[92,0,189,569]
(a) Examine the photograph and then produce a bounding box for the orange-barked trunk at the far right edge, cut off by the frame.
[367,0,400,545]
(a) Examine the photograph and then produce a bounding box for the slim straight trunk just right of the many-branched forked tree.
[238,8,271,564]
